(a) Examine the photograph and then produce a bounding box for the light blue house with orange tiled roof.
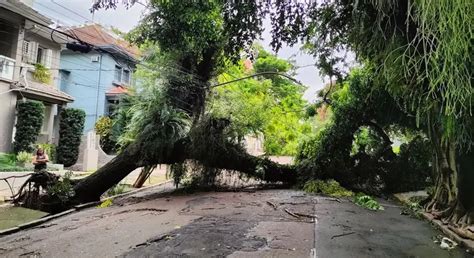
[60,24,138,133]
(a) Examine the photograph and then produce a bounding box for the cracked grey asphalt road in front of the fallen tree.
[0,185,472,257]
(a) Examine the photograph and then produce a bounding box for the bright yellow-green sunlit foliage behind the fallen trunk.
[208,47,311,155]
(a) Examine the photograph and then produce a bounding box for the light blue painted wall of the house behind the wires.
[60,51,130,133]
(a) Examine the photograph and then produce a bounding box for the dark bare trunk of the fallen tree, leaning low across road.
[73,135,296,203]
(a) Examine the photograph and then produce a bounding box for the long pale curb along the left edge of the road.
[0,180,172,237]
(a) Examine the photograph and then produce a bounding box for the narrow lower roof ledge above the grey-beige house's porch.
[12,80,74,103]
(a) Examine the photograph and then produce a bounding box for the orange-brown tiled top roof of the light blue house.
[64,24,140,59]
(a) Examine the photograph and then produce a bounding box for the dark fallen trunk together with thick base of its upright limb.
[74,119,296,202]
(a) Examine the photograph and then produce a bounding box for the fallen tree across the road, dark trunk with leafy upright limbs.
[68,1,295,203]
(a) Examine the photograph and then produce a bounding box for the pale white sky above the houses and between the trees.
[26,0,325,101]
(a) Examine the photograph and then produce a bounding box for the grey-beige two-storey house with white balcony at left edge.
[0,0,73,152]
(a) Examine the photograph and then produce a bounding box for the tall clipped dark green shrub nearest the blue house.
[57,108,86,167]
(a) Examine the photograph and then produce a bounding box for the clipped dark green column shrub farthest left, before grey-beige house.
[13,101,44,153]
